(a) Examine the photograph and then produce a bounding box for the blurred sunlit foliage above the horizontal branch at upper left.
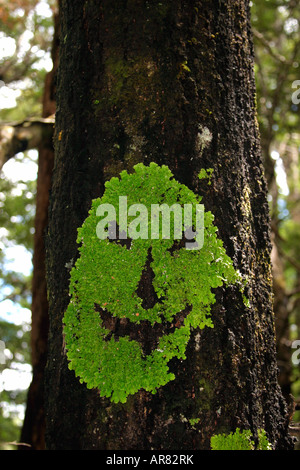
[0,0,56,121]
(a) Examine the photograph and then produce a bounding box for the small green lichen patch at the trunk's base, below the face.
[211,428,271,450]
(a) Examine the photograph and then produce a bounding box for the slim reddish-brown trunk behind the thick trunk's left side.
[19,14,59,450]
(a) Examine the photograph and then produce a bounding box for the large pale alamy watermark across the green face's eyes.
[96,196,204,250]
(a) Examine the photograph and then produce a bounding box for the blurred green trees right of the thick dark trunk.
[252,0,300,419]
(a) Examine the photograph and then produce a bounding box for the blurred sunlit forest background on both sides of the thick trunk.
[0,0,300,449]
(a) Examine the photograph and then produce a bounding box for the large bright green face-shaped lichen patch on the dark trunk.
[64,163,240,402]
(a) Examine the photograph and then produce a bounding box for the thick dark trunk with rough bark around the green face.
[46,0,292,450]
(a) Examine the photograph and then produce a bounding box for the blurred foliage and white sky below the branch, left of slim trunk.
[0,155,36,449]
